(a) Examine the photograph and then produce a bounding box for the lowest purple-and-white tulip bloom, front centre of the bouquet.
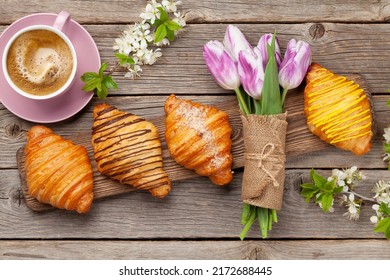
[238,47,264,99]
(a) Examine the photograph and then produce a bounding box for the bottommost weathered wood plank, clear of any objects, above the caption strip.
[0,239,390,260]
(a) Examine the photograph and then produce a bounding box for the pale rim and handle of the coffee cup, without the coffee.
[2,11,77,100]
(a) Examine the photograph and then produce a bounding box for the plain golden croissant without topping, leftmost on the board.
[24,126,93,213]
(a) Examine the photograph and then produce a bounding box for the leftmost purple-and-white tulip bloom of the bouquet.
[203,41,241,90]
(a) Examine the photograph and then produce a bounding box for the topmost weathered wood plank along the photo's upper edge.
[0,0,390,24]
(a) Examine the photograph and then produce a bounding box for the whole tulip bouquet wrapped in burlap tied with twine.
[203,25,311,240]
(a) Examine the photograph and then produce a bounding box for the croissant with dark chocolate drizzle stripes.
[92,104,171,198]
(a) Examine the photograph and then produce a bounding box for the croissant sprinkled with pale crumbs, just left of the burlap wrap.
[165,94,233,186]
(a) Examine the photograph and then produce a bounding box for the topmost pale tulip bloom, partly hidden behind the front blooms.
[223,24,252,61]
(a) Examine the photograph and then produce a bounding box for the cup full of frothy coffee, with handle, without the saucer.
[2,11,77,100]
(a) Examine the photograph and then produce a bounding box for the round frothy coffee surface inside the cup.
[7,30,73,95]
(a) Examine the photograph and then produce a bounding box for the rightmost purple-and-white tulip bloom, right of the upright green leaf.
[279,39,311,91]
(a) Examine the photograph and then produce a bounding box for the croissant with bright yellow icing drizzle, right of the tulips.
[304,63,373,155]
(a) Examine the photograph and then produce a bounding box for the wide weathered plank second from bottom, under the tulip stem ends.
[0,169,390,240]
